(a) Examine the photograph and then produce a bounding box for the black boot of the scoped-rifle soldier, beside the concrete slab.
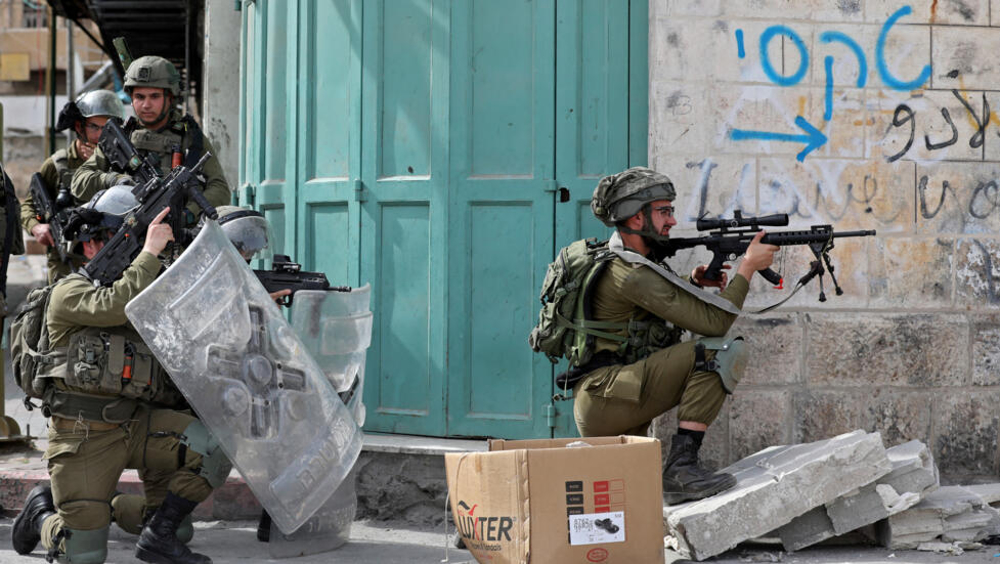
[663,435,736,505]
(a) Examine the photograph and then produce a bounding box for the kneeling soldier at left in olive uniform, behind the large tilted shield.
[11,192,231,564]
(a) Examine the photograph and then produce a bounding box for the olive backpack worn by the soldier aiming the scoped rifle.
[528,238,628,366]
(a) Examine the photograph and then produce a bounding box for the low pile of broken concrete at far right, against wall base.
[876,486,1000,549]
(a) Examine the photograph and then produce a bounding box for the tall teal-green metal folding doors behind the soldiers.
[239,0,646,438]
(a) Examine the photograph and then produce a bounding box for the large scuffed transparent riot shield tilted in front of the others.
[125,221,361,533]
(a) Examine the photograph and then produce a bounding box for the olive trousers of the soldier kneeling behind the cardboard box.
[573,341,726,437]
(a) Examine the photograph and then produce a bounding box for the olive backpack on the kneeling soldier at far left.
[7,284,55,405]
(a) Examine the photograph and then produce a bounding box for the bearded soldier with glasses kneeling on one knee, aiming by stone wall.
[571,167,777,504]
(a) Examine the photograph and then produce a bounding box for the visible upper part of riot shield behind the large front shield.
[292,284,372,427]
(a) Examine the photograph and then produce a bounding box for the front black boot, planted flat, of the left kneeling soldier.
[135,492,212,564]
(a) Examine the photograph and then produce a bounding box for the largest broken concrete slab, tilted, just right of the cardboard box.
[663,431,892,560]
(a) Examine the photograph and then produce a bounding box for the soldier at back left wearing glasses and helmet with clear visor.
[21,90,125,284]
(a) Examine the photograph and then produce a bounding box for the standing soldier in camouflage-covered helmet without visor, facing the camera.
[71,56,231,215]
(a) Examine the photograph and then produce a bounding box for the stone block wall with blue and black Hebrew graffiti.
[649,0,1000,482]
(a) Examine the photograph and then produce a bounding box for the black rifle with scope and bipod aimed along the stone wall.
[662,210,875,302]
